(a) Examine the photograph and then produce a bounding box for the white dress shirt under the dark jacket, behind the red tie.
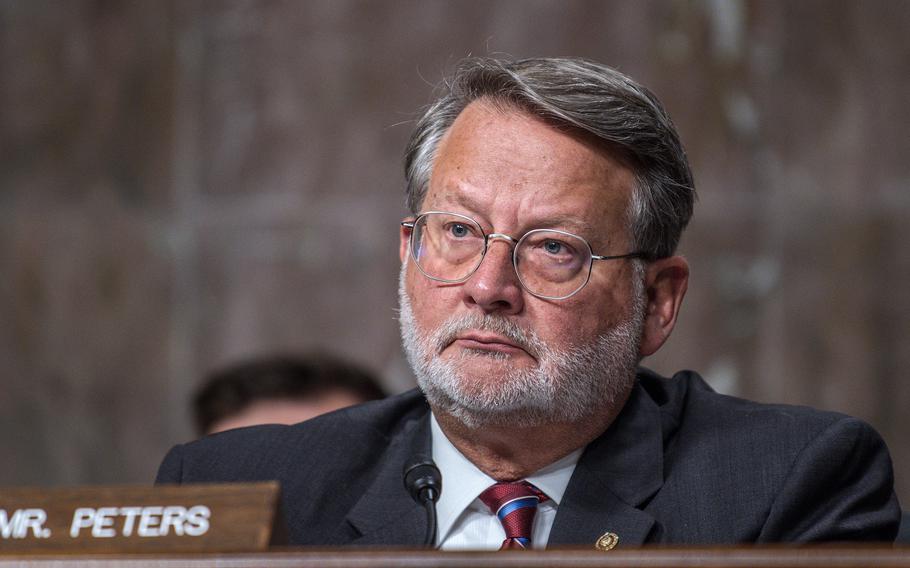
[430,415,584,550]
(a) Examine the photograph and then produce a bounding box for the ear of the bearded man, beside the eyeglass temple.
[639,256,689,357]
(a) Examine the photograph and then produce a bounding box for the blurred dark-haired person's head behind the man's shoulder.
[193,355,385,436]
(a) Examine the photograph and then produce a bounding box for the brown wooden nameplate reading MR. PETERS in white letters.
[0,482,284,553]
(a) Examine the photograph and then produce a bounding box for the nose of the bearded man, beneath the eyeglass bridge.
[462,233,524,314]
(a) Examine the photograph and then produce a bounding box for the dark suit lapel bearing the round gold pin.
[548,382,663,547]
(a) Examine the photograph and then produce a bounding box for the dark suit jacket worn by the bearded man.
[158,370,900,547]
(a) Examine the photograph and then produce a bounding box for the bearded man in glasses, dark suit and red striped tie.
[158,59,899,549]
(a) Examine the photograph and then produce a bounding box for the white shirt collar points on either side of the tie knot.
[430,413,584,542]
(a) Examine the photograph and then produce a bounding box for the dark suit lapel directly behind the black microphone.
[346,404,431,546]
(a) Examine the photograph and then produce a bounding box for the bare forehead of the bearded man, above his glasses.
[422,102,634,234]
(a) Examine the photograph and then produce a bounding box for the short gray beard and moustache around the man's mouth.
[398,264,645,428]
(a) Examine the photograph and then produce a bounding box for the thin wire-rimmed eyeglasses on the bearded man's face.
[401,211,649,300]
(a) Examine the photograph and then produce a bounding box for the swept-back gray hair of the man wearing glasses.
[405,58,695,258]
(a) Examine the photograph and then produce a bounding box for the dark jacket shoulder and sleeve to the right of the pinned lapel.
[642,371,899,543]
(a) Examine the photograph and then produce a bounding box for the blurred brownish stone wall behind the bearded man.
[0,0,910,502]
